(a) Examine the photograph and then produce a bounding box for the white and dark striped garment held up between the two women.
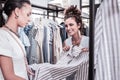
[29,37,89,80]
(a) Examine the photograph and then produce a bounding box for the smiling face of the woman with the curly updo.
[65,18,80,36]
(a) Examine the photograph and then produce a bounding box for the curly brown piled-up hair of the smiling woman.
[64,5,83,34]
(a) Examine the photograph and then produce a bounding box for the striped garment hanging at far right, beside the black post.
[94,0,120,80]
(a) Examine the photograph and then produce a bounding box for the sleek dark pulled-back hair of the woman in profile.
[0,0,30,27]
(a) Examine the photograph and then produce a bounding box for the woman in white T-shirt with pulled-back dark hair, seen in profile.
[0,0,32,80]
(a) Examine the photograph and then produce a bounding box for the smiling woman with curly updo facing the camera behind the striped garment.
[63,5,89,52]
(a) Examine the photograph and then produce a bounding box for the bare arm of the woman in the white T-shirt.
[0,56,25,80]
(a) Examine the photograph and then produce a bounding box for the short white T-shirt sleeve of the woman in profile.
[0,32,12,57]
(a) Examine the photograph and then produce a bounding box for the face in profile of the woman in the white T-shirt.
[18,3,32,27]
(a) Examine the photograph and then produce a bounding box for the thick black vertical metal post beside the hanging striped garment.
[88,0,95,80]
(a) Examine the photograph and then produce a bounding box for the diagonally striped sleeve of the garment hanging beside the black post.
[94,4,103,69]
